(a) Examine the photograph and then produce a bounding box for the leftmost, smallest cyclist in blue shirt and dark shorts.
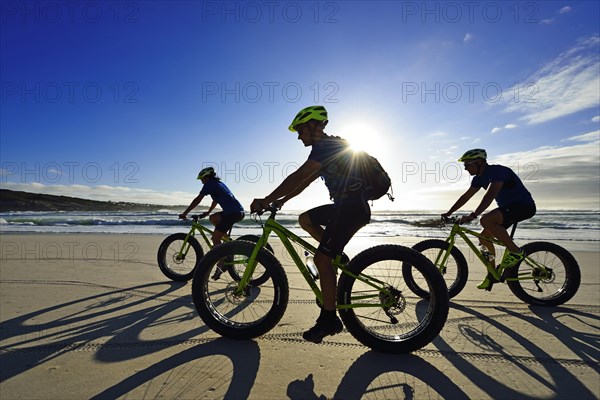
[179,167,244,280]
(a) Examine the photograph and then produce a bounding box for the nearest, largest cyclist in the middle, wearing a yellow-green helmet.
[250,106,371,343]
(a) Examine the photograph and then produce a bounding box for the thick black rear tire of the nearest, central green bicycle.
[337,245,449,354]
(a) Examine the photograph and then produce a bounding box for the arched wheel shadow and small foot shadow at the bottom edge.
[287,351,469,400]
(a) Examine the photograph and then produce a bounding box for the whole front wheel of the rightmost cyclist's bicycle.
[402,239,469,298]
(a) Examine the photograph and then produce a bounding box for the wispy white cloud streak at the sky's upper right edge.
[499,36,600,124]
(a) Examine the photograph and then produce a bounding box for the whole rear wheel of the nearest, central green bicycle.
[338,245,449,353]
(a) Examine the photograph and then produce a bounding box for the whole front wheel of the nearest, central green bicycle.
[192,240,289,339]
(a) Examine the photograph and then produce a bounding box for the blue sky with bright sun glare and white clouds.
[0,0,600,210]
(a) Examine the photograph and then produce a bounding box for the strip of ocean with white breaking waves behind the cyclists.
[0,210,600,245]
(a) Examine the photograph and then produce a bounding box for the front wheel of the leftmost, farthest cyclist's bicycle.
[157,233,204,282]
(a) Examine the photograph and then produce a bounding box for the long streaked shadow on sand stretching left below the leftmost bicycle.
[0,282,208,382]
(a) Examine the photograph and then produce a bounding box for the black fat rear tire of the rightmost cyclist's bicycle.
[507,242,581,307]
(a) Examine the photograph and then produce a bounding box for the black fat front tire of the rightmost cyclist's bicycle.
[402,239,469,299]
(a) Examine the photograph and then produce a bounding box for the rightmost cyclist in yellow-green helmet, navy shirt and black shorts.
[442,149,536,290]
